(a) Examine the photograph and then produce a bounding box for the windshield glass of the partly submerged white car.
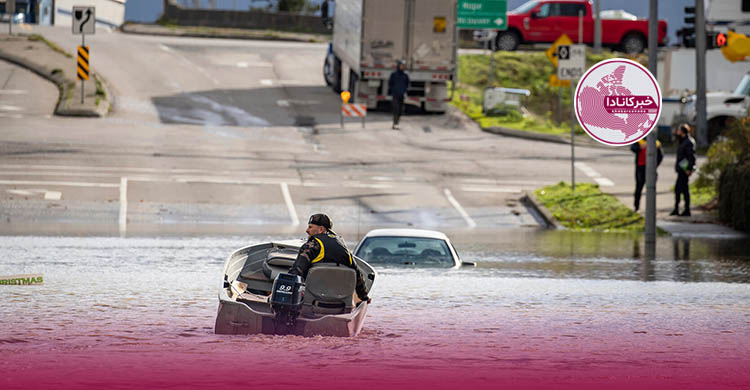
[357,237,454,267]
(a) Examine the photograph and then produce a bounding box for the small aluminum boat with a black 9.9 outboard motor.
[214,240,376,336]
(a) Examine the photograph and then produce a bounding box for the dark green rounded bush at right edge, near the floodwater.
[719,161,750,231]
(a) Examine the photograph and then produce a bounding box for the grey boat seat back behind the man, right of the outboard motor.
[302,264,357,314]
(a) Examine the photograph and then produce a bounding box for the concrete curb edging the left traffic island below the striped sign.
[0,45,112,118]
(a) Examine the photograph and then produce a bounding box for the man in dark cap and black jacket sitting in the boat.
[289,214,371,303]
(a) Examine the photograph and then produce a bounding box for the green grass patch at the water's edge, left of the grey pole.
[534,182,644,232]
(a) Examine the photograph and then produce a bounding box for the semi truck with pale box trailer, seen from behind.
[323,0,458,113]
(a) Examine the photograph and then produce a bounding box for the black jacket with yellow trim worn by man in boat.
[289,231,368,301]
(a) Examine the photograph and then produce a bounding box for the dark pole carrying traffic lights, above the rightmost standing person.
[695,0,708,147]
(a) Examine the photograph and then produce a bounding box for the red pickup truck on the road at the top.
[495,0,667,53]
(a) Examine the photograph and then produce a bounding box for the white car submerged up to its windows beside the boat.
[354,229,476,268]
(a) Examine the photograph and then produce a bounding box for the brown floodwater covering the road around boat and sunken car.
[0,230,750,389]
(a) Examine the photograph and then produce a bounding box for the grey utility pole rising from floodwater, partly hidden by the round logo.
[645,0,661,260]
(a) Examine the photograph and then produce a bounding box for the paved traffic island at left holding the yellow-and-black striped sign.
[0,33,112,117]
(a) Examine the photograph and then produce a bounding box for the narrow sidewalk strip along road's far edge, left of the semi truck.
[120,23,331,43]
